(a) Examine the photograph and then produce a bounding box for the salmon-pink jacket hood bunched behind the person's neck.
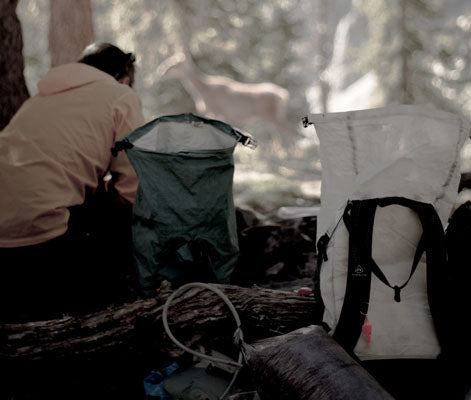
[38,63,115,96]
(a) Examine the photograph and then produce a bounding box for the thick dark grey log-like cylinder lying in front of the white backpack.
[247,326,392,400]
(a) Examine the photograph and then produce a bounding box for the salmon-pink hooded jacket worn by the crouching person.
[0,63,145,247]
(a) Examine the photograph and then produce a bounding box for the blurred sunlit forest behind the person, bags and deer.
[9,0,471,211]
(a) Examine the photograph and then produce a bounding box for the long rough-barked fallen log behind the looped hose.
[0,285,316,361]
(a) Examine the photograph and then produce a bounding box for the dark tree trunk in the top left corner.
[0,0,29,130]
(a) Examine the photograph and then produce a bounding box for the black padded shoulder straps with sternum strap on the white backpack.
[333,197,446,353]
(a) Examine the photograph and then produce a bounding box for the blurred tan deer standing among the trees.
[157,52,296,148]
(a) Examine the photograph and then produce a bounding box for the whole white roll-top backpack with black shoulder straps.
[309,105,470,360]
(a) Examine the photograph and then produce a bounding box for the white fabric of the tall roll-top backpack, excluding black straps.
[310,105,470,359]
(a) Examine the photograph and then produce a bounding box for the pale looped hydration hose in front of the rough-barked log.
[162,282,245,400]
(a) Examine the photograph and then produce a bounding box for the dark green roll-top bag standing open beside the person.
[118,114,245,296]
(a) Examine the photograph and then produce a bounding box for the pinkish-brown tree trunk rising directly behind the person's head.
[49,0,94,67]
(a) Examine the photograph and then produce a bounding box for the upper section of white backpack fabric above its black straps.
[309,105,470,237]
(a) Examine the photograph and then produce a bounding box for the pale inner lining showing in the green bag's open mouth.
[134,122,236,153]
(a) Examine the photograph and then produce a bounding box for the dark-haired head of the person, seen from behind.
[78,43,136,87]
